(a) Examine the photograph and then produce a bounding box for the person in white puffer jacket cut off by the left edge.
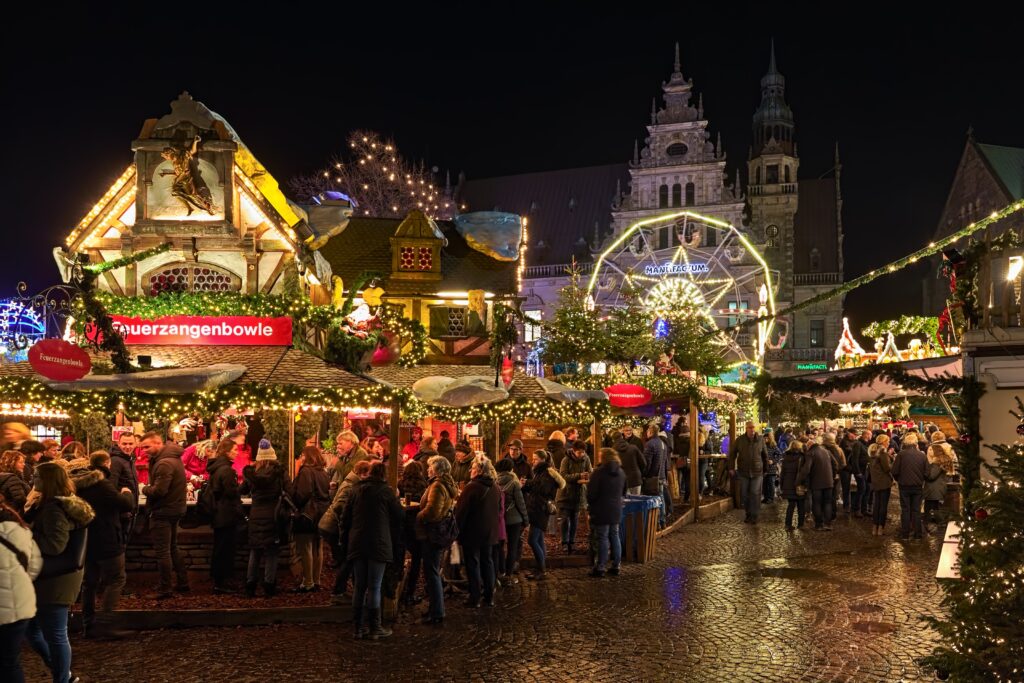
[0,495,43,683]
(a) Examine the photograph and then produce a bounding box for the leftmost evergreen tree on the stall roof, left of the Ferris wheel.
[542,261,606,364]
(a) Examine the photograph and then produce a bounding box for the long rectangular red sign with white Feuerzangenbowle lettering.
[111,315,292,346]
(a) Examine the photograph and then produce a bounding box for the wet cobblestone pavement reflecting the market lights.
[25,503,941,683]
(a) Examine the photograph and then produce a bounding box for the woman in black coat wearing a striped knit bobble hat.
[241,438,288,598]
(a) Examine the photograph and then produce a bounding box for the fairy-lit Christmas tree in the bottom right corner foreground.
[926,405,1024,681]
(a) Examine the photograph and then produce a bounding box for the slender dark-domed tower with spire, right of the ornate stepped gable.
[746,41,800,302]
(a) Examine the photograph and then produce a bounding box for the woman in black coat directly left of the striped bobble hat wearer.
[206,438,245,593]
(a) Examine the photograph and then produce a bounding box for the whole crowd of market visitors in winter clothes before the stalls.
[0,413,957,683]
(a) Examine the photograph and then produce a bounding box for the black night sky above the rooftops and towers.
[0,3,1024,329]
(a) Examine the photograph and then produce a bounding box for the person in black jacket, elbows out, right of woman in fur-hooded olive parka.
[71,451,135,638]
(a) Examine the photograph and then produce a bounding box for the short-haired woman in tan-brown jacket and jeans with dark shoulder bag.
[416,456,459,625]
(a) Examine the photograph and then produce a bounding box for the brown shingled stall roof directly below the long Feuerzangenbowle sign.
[0,344,378,389]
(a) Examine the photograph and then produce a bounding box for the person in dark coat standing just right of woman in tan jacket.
[455,456,502,607]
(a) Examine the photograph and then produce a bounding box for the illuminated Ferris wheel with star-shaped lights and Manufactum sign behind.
[587,211,777,362]
